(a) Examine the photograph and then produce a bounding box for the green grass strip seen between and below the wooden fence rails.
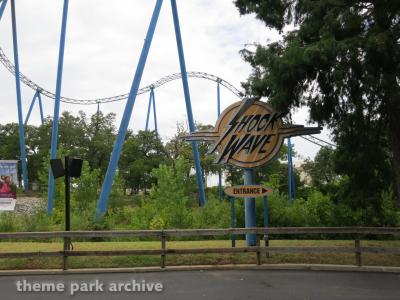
[0,240,400,270]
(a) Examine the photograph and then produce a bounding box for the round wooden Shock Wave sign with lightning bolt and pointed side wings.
[185,98,321,168]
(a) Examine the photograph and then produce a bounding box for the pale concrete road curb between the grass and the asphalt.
[0,264,400,276]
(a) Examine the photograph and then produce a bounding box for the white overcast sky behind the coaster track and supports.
[0,0,327,161]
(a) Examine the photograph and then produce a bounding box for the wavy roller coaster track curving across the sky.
[0,47,244,105]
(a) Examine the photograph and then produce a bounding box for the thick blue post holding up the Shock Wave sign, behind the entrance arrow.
[243,169,256,246]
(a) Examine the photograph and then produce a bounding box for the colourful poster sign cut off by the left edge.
[0,160,18,211]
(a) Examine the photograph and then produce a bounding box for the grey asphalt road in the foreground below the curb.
[0,270,400,300]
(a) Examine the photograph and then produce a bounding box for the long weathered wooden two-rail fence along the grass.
[0,227,400,270]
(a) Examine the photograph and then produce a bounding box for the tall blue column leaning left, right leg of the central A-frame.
[171,0,206,206]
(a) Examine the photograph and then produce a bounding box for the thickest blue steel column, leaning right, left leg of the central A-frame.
[96,0,163,217]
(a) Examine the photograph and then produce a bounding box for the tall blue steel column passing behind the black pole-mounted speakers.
[47,0,69,214]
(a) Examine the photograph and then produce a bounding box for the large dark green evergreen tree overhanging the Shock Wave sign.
[235,0,400,201]
